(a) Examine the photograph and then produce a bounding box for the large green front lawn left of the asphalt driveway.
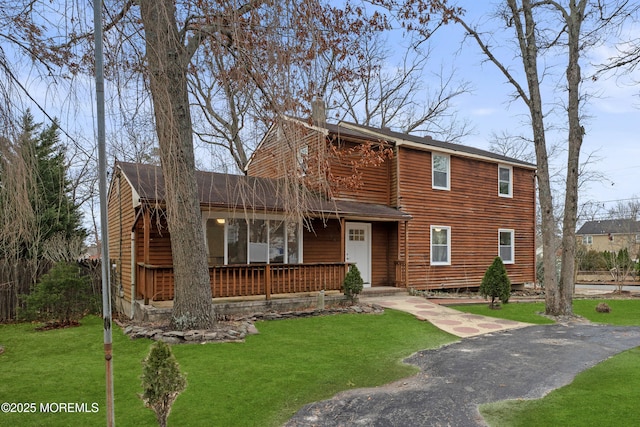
[0,310,456,426]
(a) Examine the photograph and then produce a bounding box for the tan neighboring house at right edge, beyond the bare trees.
[576,219,640,258]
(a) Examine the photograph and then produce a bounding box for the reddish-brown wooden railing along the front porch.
[136,262,349,304]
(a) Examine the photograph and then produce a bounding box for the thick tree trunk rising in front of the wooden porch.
[139,0,215,330]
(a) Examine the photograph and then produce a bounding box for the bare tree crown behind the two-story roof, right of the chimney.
[325,34,470,142]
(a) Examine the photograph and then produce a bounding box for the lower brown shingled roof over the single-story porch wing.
[116,162,411,221]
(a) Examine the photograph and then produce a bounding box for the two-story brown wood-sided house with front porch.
[108,112,536,316]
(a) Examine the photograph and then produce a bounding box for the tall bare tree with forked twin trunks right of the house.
[458,0,627,315]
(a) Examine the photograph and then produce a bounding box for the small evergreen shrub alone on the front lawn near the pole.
[140,341,187,427]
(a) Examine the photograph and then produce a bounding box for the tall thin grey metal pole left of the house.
[93,0,115,427]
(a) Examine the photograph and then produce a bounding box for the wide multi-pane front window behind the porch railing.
[206,218,302,265]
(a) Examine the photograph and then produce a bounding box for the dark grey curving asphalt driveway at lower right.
[286,323,640,427]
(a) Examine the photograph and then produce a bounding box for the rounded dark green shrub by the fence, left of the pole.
[21,262,96,325]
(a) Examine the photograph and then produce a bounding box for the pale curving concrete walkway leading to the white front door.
[360,295,531,338]
